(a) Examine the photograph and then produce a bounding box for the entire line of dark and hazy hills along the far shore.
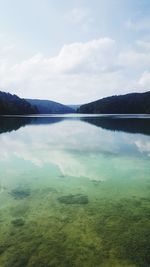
[0,91,150,115]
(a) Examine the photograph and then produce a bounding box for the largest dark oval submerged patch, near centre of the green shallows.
[58,194,89,204]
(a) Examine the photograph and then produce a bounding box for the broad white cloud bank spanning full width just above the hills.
[0,35,150,103]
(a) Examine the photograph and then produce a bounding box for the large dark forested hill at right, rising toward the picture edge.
[77,91,150,114]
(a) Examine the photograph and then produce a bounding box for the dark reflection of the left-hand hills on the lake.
[0,117,63,134]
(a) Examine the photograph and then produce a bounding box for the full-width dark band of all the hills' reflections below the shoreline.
[0,115,150,135]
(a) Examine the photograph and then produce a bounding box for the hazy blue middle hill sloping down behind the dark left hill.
[26,99,75,114]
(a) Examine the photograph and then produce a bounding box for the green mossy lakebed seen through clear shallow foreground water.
[0,186,150,267]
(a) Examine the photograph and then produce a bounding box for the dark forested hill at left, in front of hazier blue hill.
[0,91,38,115]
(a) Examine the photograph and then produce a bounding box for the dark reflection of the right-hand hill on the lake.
[81,117,150,135]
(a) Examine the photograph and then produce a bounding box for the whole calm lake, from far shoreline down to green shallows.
[0,115,150,267]
